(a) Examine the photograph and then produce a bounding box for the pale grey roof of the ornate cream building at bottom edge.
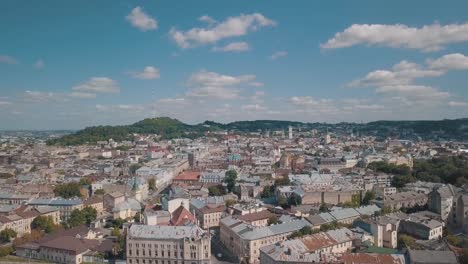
[128,225,206,240]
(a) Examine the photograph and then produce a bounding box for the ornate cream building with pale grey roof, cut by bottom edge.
[126,225,211,264]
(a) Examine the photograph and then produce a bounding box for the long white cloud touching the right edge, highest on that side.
[321,23,468,52]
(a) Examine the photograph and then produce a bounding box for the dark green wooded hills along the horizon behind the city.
[47,117,468,145]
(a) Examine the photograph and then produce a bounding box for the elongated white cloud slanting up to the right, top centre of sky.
[169,13,276,49]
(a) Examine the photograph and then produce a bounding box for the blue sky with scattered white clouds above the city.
[0,0,468,130]
